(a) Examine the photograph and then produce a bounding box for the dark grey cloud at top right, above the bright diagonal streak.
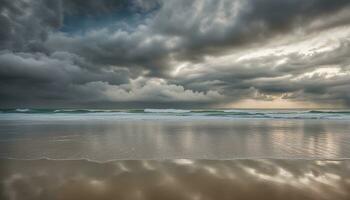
[152,0,350,59]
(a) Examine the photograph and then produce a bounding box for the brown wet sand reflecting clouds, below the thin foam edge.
[0,159,350,200]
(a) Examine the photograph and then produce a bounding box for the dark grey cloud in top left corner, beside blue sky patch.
[0,0,63,51]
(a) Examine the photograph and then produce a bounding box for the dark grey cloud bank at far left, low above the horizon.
[0,52,129,107]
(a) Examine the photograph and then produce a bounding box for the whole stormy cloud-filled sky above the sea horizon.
[0,0,350,108]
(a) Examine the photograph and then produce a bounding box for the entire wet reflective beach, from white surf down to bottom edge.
[0,111,350,200]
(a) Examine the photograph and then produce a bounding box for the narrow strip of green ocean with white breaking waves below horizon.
[0,108,350,120]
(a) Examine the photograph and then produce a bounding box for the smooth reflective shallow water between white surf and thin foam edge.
[0,119,350,161]
